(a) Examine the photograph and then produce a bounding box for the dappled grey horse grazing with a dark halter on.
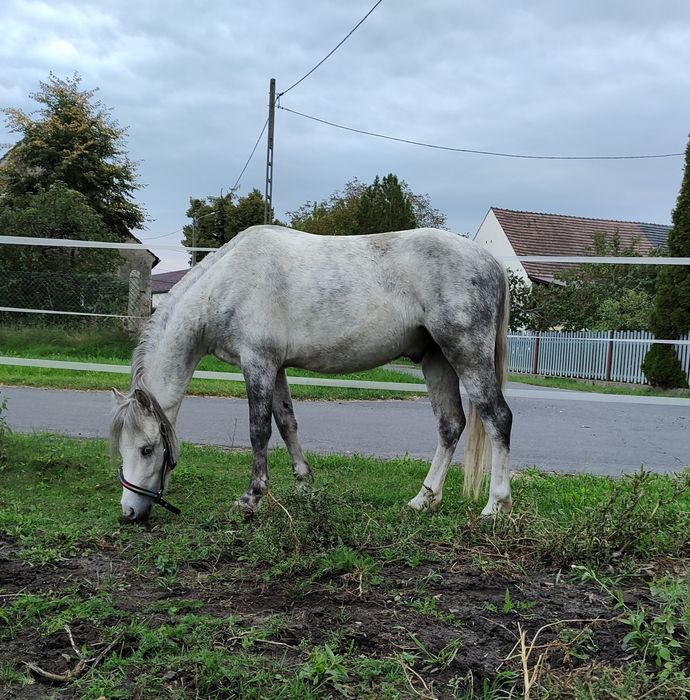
[110,226,512,521]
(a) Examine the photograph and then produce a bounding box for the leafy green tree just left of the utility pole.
[183,189,266,261]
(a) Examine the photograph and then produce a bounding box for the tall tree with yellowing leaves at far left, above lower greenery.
[0,73,146,240]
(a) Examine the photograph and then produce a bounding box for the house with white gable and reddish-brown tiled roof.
[474,207,670,284]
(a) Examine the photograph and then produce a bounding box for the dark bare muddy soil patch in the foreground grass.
[0,539,644,698]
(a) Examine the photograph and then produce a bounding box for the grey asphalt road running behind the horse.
[2,387,690,475]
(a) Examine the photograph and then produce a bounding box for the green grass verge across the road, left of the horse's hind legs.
[0,326,424,400]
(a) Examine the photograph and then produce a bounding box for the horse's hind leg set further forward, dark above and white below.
[408,346,465,511]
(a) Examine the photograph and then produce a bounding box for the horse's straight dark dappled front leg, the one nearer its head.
[238,357,276,514]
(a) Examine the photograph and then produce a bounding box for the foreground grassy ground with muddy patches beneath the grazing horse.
[0,434,690,700]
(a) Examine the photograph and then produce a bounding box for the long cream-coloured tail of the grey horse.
[463,272,510,500]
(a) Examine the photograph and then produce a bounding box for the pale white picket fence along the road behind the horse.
[508,331,690,384]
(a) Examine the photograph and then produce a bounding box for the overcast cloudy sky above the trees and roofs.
[0,0,690,271]
